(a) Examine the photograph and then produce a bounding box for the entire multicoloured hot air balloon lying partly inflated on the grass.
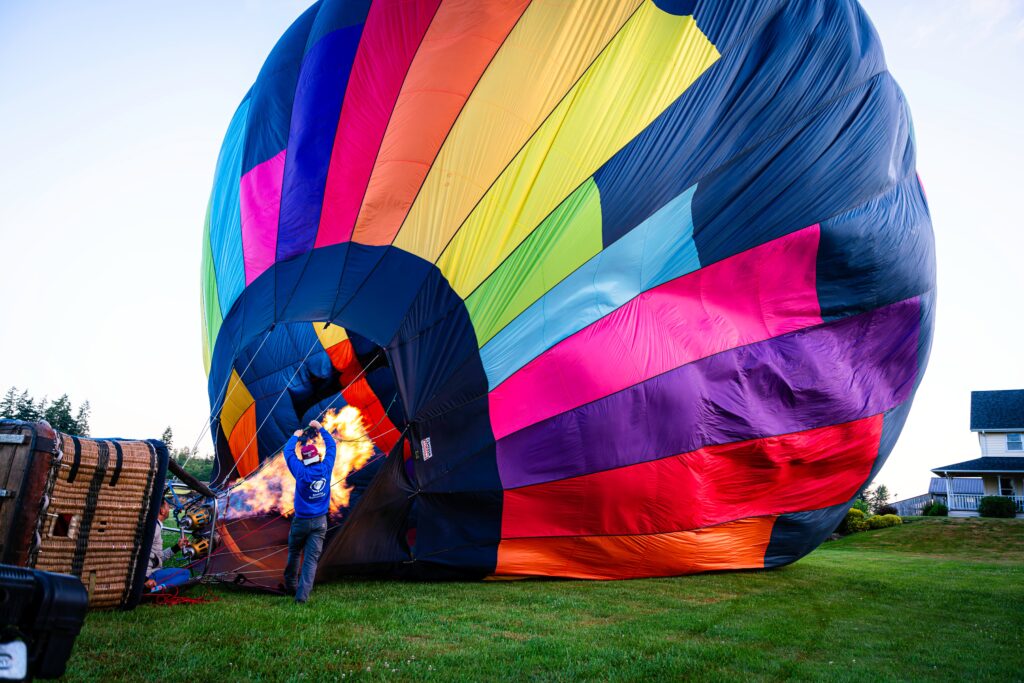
[202,0,935,586]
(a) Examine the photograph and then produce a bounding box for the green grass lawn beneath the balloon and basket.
[67,518,1024,683]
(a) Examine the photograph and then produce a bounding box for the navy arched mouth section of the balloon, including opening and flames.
[204,244,501,588]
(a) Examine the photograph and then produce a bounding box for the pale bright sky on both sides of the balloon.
[0,0,1024,498]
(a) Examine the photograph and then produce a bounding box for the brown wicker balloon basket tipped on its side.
[0,421,168,608]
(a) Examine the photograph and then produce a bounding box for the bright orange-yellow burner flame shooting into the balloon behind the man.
[221,405,374,519]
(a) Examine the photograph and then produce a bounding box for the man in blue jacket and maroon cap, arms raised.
[285,420,337,603]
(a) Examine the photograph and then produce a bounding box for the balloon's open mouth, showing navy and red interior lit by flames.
[209,321,406,524]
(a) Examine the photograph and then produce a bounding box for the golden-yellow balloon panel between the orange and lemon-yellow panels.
[394,0,640,262]
